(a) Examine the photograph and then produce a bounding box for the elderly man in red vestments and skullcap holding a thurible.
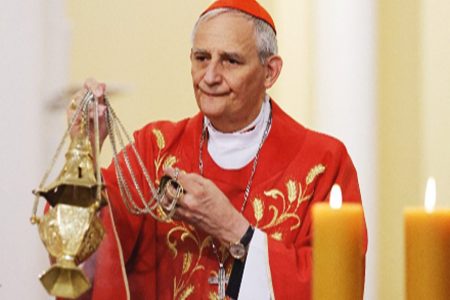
[70,0,361,299]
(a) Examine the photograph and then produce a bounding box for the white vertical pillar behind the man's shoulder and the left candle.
[313,0,378,299]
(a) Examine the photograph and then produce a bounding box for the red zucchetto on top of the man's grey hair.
[201,0,277,33]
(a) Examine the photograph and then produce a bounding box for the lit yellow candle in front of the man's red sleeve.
[312,185,364,300]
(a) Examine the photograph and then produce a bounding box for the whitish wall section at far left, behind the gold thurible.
[0,0,67,299]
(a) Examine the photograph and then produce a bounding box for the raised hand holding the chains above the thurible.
[67,78,108,148]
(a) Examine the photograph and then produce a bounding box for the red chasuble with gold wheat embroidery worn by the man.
[84,101,366,300]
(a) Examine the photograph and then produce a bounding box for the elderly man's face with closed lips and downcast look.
[191,12,266,132]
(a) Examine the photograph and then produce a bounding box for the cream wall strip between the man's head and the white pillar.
[269,0,315,127]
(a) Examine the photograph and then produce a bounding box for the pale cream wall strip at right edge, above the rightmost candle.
[417,0,450,207]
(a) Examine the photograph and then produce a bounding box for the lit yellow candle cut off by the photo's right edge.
[404,178,450,300]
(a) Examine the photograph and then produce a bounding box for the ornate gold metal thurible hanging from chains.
[30,93,104,299]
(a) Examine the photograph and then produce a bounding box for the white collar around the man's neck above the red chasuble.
[205,95,271,170]
